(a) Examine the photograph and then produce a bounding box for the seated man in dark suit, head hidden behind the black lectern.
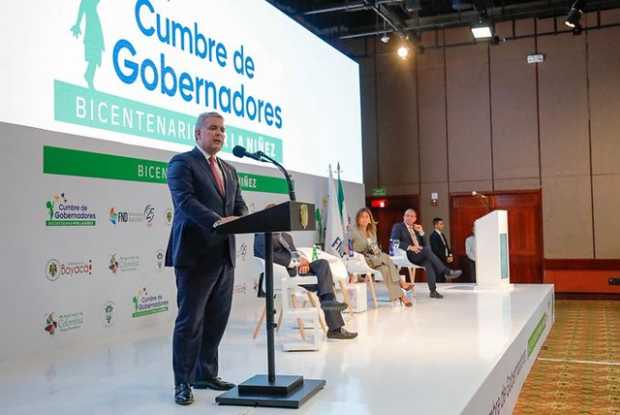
[254,231,357,339]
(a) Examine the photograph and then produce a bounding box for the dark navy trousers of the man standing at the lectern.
[172,262,234,385]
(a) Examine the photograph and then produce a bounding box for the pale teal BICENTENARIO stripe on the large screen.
[54,80,283,163]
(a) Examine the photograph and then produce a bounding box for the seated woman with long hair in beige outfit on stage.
[352,208,413,307]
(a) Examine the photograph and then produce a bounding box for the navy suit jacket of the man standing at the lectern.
[166,148,248,268]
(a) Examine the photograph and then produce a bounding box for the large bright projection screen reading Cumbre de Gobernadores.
[0,0,363,183]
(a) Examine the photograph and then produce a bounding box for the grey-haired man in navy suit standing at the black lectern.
[166,112,248,405]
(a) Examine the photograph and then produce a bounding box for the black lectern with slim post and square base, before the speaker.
[215,201,326,408]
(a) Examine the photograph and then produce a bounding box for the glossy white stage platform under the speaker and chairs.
[0,284,554,415]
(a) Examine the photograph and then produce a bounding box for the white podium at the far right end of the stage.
[474,210,510,288]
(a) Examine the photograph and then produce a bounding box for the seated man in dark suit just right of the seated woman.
[390,209,463,298]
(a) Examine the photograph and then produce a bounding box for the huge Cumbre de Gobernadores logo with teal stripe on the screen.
[54,0,285,161]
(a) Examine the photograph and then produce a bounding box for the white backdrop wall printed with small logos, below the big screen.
[0,123,364,363]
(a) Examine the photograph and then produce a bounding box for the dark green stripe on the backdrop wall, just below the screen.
[43,146,288,194]
